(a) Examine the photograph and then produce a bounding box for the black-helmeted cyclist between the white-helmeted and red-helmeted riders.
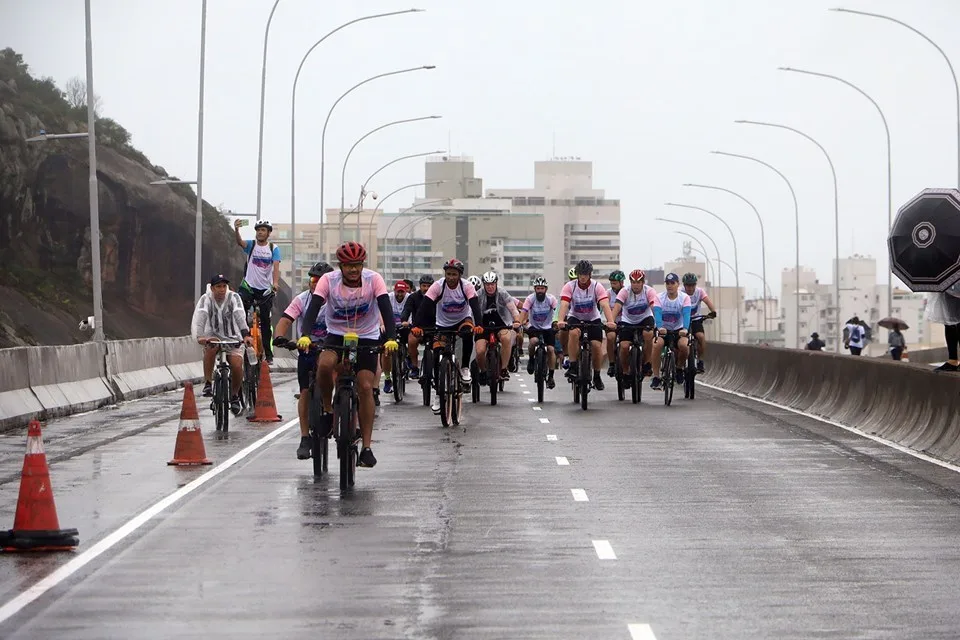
[557,260,616,391]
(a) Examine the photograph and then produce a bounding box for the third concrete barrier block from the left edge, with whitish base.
[104,338,179,400]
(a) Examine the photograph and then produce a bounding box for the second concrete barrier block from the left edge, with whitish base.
[27,342,116,419]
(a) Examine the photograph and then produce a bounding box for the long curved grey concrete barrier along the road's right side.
[703,343,960,463]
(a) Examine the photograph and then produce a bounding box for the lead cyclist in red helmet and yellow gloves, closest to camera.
[297,242,399,467]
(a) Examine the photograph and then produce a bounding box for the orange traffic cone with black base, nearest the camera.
[0,420,80,551]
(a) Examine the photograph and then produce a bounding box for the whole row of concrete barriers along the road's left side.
[0,336,297,430]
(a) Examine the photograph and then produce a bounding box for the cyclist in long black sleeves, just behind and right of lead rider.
[411,258,483,411]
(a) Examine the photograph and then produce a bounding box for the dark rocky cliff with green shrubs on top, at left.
[0,49,274,347]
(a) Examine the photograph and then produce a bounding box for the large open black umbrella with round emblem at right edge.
[887,189,960,291]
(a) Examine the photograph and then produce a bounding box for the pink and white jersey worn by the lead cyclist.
[313,269,388,340]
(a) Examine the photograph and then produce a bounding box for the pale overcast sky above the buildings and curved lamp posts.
[0,0,960,294]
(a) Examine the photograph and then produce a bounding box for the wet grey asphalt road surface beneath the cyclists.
[0,373,960,640]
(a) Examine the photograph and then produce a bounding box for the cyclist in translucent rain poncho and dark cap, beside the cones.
[190,273,253,416]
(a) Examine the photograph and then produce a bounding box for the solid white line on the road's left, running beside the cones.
[0,412,299,623]
